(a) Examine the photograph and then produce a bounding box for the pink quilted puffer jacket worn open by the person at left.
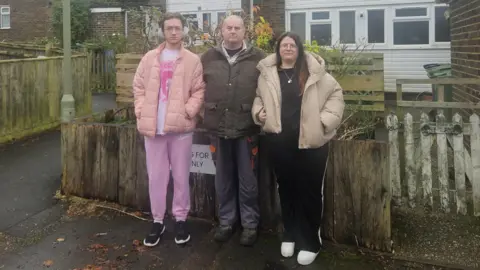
[133,43,205,137]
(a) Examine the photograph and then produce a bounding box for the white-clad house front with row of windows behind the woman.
[285,0,451,93]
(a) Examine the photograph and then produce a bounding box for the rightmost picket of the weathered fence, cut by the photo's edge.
[470,114,480,217]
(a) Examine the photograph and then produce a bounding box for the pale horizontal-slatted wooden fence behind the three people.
[116,53,385,112]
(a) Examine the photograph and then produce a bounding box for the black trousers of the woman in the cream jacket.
[266,134,328,253]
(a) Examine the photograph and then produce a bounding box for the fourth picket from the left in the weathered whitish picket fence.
[436,110,450,213]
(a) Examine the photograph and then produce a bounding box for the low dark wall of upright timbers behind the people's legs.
[62,108,391,251]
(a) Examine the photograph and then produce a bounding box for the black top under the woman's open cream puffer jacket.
[278,68,302,134]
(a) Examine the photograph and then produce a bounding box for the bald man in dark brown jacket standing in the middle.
[202,15,265,246]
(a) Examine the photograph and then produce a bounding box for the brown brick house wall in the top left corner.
[0,0,52,41]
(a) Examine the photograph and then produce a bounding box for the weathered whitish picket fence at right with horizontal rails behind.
[386,78,480,216]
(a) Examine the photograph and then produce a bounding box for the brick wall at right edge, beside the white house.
[450,0,480,108]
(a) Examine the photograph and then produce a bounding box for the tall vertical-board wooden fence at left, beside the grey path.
[0,56,91,143]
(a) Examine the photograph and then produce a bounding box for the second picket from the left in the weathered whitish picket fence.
[404,113,417,208]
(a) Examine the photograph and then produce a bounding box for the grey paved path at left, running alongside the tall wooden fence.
[0,94,115,232]
